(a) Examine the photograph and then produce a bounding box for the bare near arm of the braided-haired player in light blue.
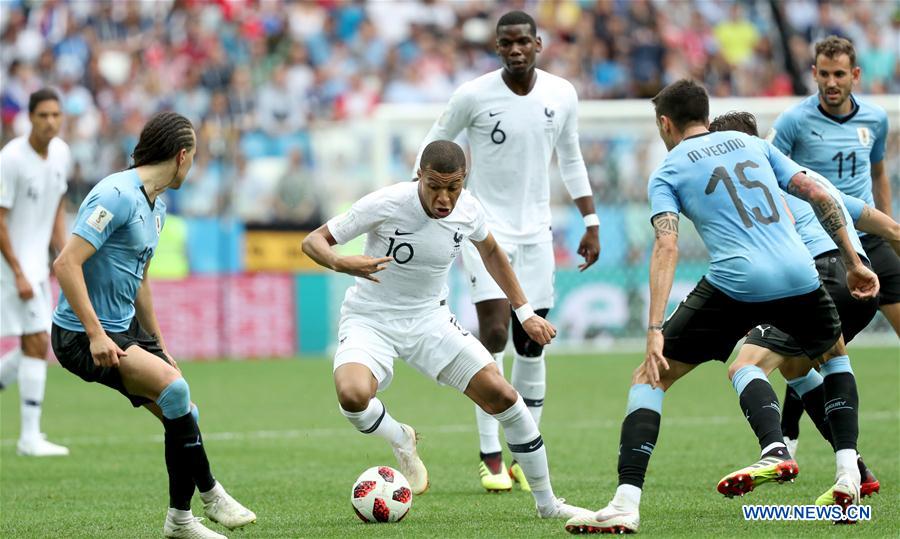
[53,234,125,367]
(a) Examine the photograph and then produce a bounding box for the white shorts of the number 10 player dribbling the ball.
[334,306,494,391]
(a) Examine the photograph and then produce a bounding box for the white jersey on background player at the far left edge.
[0,136,72,286]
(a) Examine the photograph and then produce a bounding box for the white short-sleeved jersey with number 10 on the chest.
[327,182,488,319]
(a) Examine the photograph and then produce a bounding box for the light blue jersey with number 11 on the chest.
[768,94,888,206]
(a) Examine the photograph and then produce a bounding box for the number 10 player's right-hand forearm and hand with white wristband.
[472,233,556,346]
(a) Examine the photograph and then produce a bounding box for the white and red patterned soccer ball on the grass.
[350,466,412,522]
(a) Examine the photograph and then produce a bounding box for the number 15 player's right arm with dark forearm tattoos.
[788,172,878,299]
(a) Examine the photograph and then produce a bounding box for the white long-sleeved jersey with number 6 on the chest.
[416,69,591,243]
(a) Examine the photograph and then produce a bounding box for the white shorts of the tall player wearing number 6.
[462,241,556,309]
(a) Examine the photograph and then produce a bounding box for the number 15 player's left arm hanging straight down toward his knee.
[644,212,678,388]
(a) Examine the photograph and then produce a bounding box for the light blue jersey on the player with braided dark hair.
[53,169,166,332]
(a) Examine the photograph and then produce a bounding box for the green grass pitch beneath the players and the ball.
[0,348,900,538]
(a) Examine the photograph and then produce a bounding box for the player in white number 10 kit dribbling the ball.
[303,140,583,518]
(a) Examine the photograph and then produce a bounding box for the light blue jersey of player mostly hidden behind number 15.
[784,170,868,259]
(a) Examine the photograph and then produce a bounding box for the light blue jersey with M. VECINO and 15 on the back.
[648,131,819,302]
